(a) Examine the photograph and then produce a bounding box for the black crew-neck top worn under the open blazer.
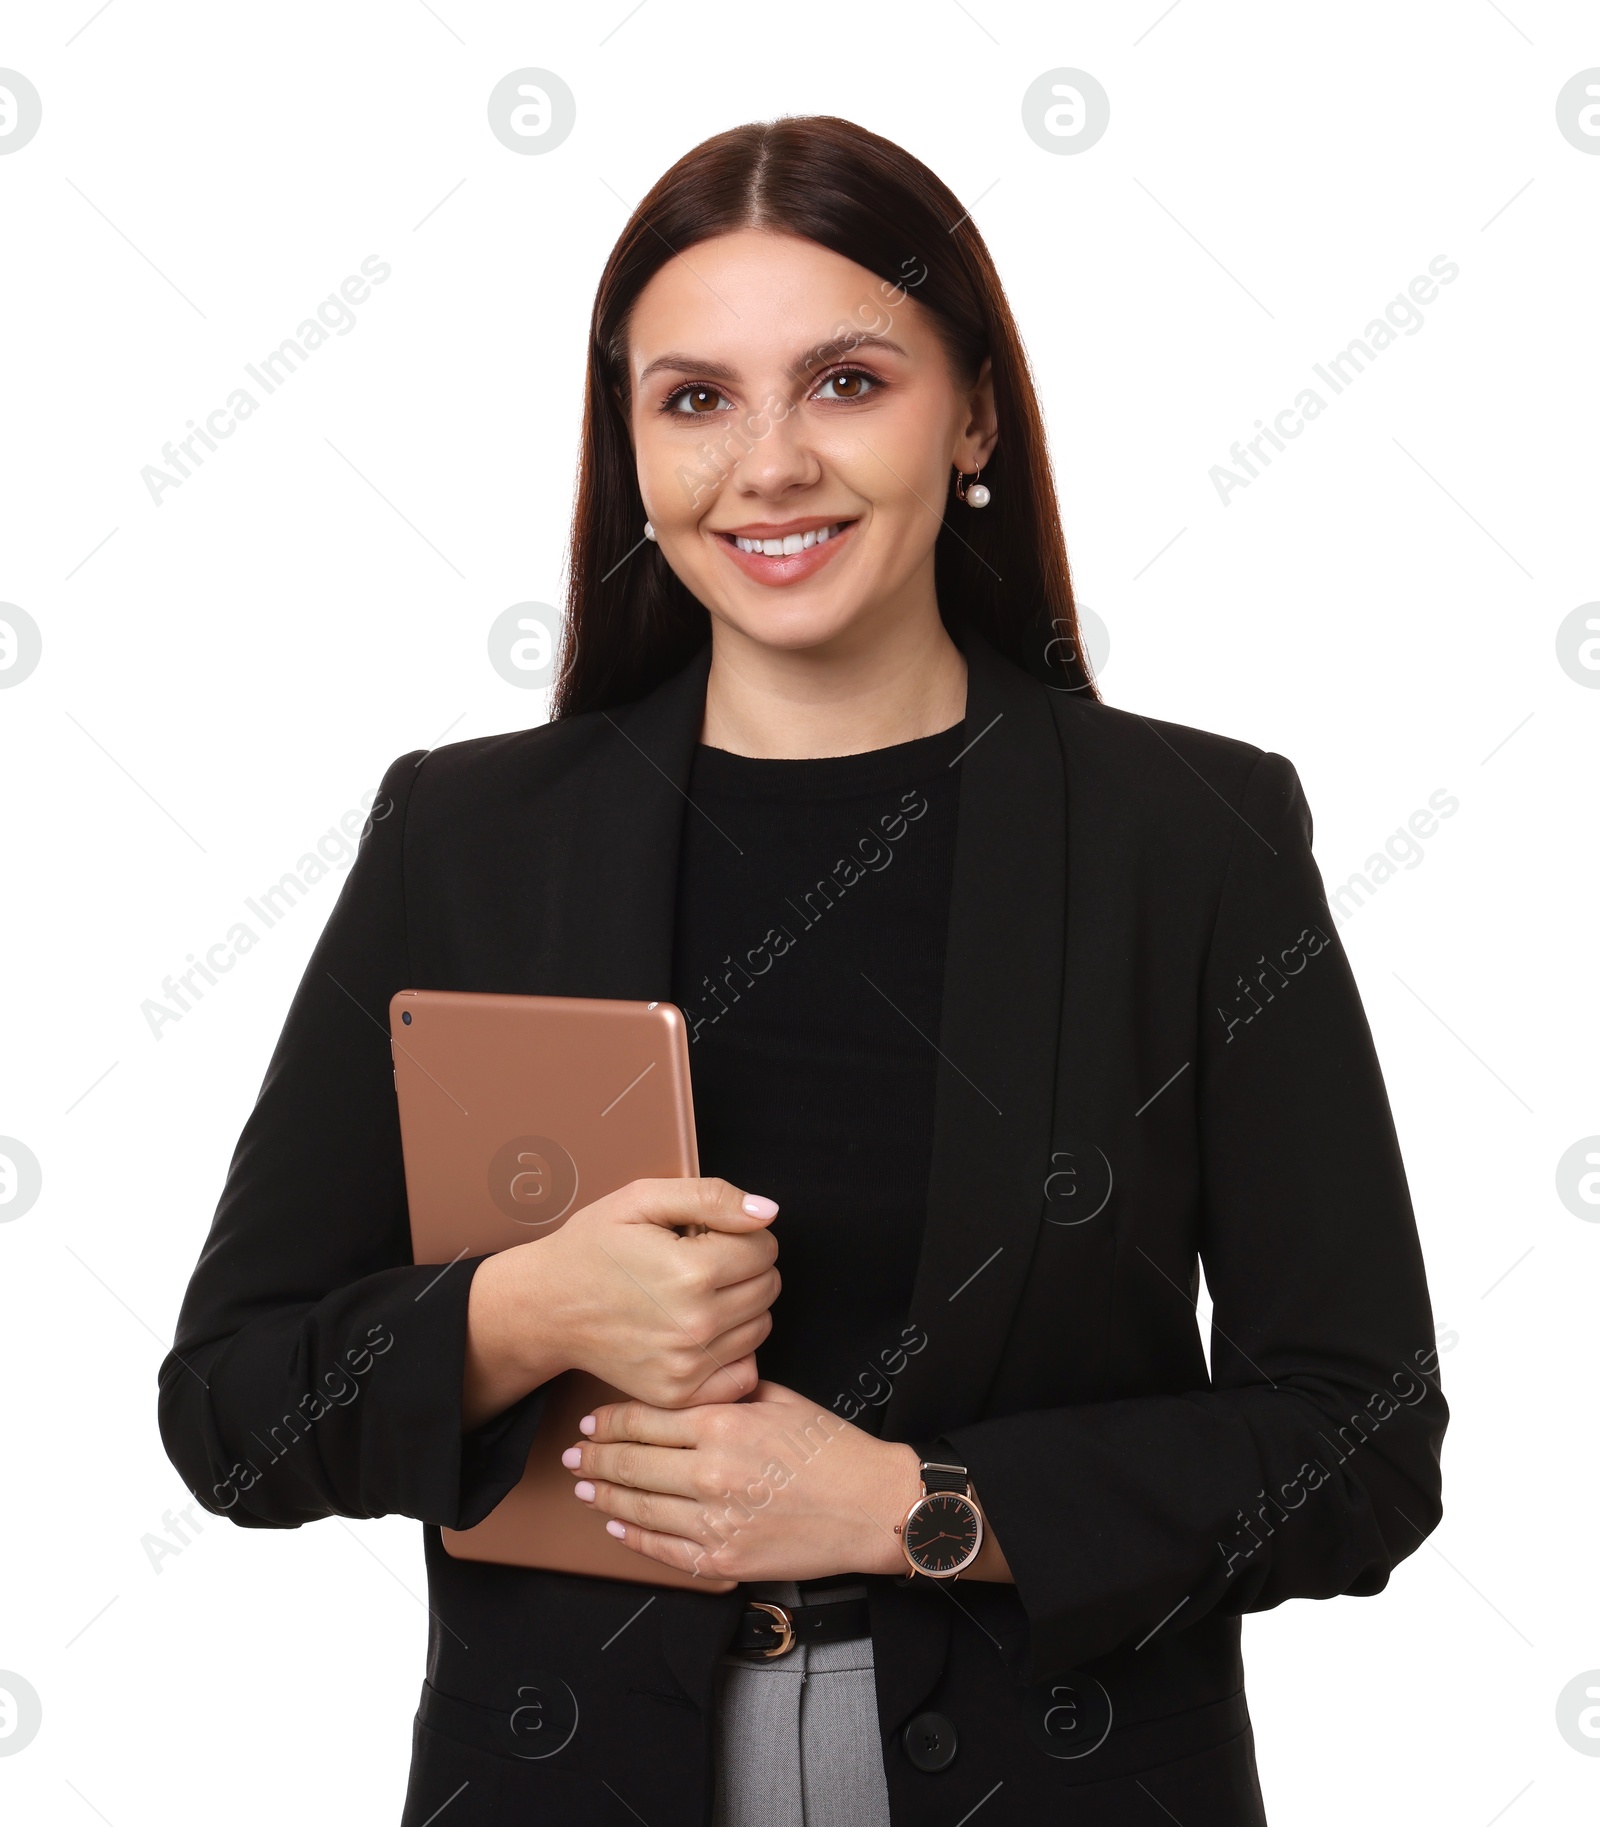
[672,723,966,1429]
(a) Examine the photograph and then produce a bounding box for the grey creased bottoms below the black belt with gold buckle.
[712,1580,889,1827]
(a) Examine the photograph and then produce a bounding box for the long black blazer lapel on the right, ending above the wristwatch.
[882,630,1067,1442]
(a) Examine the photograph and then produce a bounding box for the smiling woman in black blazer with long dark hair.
[161,117,1447,1827]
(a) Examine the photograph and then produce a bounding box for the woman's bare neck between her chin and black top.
[700,605,966,760]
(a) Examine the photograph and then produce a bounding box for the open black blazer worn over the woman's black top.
[161,632,1447,1827]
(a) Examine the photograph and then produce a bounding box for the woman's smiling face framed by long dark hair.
[628,230,995,665]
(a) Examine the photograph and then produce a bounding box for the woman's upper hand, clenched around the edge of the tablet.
[462,1178,780,1432]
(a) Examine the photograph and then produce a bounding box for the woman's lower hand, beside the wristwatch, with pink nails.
[563,1383,922,1580]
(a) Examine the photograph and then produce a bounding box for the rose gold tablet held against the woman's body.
[389,990,734,1591]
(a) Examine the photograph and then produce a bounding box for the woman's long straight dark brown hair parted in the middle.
[552,115,1098,718]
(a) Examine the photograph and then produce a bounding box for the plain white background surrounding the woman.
[0,0,1600,1827]
